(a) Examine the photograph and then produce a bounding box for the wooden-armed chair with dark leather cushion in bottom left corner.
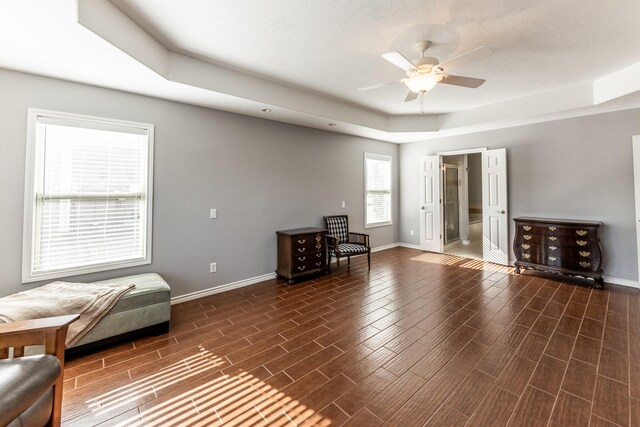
[0,314,79,427]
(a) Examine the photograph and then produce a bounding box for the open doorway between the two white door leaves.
[442,153,483,259]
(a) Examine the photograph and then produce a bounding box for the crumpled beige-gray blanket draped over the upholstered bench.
[0,282,134,347]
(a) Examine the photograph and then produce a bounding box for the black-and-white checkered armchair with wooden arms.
[323,215,371,270]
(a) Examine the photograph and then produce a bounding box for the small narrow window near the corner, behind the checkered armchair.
[364,153,391,228]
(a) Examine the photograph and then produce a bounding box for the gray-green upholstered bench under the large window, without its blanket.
[67,273,171,355]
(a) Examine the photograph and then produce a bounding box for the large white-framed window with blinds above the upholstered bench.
[22,109,153,282]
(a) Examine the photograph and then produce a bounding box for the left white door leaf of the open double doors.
[420,156,442,252]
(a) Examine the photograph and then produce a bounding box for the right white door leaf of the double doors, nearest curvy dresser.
[482,148,509,265]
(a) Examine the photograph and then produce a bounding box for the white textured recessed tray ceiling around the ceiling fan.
[112,0,640,114]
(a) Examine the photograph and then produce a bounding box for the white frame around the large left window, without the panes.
[22,108,154,283]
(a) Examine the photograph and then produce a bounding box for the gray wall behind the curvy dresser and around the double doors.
[400,109,640,281]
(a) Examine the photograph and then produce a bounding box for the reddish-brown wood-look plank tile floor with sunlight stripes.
[63,248,640,427]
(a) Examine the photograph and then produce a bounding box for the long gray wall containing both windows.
[0,70,399,296]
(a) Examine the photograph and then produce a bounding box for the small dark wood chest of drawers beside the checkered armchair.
[276,227,327,283]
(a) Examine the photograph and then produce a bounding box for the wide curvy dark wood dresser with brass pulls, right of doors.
[513,217,603,289]
